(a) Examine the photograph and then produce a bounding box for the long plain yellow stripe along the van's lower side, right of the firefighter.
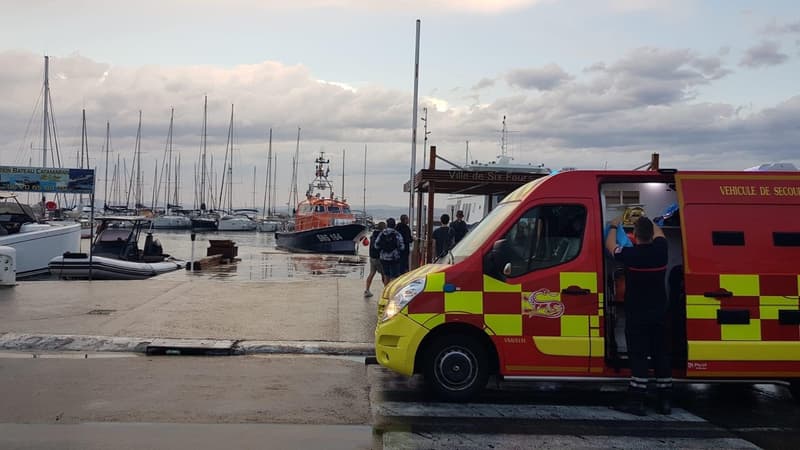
[689,341,800,361]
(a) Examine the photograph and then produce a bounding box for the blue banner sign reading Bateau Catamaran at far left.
[0,166,94,194]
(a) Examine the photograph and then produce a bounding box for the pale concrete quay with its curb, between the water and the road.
[0,278,380,355]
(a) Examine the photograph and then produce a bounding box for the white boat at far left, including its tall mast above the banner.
[0,56,81,278]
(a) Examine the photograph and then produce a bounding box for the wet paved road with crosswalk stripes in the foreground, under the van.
[0,353,800,449]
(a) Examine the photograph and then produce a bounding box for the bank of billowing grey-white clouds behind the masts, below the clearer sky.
[0,48,800,204]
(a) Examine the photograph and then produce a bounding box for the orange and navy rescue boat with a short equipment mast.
[275,152,367,255]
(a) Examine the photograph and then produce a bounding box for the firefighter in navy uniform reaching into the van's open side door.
[606,217,672,416]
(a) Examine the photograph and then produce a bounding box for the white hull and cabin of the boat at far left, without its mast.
[0,195,81,278]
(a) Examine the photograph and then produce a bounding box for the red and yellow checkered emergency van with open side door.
[375,170,800,401]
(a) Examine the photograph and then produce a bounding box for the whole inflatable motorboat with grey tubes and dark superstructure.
[49,216,186,280]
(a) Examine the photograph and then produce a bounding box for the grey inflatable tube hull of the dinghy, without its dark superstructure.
[49,253,186,280]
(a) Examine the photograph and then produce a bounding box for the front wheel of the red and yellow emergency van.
[423,334,489,402]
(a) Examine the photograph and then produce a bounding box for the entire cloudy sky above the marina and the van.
[0,0,800,208]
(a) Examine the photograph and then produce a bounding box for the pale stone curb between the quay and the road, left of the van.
[0,333,375,356]
